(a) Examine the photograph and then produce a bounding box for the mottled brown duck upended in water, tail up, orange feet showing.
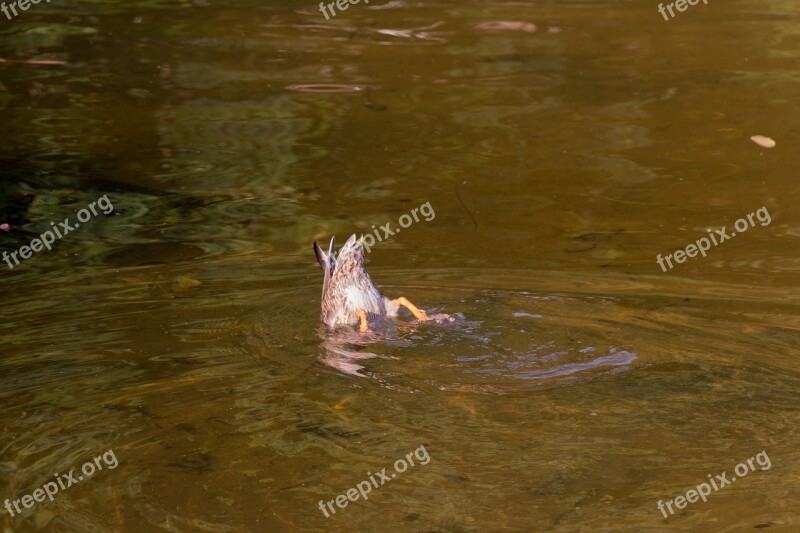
[314,234,440,334]
